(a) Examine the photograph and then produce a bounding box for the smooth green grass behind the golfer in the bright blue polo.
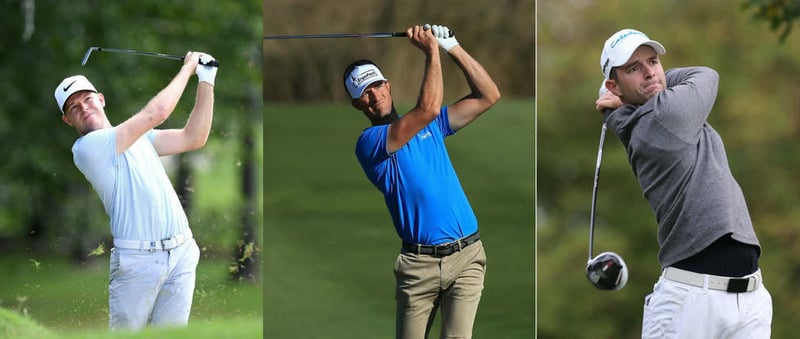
[264,100,534,338]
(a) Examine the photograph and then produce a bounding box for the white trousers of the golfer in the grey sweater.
[642,273,772,339]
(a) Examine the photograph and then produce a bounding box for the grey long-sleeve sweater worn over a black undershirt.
[606,67,761,268]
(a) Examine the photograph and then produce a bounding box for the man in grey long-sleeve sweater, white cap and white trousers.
[595,29,772,338]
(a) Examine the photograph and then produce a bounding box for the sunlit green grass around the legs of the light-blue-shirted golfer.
[0,254,263,338]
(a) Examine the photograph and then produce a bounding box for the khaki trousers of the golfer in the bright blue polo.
[394,240,486,339]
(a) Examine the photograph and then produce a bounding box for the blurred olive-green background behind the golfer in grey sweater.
[536,0,800,338]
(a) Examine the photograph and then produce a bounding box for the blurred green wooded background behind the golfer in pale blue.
[0,0,263,337]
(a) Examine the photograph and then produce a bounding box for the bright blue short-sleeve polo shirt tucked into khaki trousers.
[356,106,478,245]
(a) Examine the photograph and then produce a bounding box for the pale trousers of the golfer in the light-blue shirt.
[108,239,200,330]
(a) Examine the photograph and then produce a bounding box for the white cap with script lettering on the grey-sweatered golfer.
[600,28,667,79]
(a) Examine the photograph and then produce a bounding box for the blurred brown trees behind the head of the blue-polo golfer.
[264,0,535,102]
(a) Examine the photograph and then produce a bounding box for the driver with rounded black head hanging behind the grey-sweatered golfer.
[586,84,628,291]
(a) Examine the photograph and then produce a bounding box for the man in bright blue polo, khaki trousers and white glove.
[343,25,500,338]
